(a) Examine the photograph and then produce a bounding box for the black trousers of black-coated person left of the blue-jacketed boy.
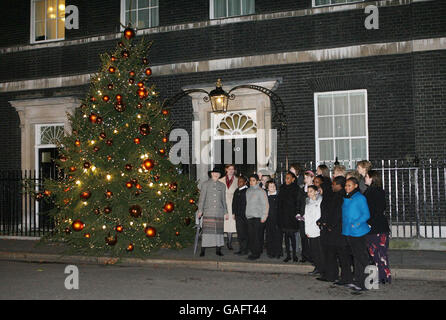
[322,244,353,283]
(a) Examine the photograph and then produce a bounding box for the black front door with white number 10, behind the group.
[214,138,257,176]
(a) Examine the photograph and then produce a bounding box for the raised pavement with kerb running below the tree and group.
[0,239,446,281]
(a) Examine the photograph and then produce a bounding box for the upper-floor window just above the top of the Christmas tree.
[121,0,159,29]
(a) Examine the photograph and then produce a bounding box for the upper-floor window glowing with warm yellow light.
[31,0,65,43]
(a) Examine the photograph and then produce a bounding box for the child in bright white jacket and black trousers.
[305,185,324,276]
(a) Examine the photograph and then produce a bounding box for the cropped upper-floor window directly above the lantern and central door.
[210,0,255,19]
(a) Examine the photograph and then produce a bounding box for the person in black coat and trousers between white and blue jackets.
[317,176,353,285]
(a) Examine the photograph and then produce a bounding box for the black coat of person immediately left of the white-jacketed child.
[278,183,303,232]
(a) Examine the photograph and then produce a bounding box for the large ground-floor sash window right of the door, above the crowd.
[314,90,368,168]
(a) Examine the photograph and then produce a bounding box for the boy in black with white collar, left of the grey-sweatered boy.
[232,176,248,255]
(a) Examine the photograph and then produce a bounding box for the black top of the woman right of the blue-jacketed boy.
[364,185,390,234]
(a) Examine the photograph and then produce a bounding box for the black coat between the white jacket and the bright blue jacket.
[319,190,347,246]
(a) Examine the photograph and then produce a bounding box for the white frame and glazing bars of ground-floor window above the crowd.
[314,89,369,168]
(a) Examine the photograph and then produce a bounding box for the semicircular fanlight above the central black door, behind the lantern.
[215,111,257,139]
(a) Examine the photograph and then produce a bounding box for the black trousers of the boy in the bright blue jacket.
[347,236,370,288]
